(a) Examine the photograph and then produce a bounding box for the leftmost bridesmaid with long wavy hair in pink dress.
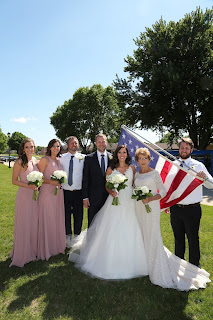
[10,138,39,267]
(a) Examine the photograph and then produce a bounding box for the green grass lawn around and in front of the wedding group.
[0,165,213,320]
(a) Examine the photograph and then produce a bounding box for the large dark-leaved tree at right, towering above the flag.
[114,8,213,149]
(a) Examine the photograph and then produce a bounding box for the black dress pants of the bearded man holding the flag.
[170,204,202,266]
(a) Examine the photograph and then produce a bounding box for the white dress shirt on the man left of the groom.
[60,152,85,191]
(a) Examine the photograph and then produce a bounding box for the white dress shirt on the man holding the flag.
[174,157,213,205]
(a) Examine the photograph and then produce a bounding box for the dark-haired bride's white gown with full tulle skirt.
[69,167,148,280]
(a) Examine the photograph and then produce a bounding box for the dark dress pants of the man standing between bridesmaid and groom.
[64,190,83,235]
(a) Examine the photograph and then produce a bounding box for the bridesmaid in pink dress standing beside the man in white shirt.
[38,139,66,260]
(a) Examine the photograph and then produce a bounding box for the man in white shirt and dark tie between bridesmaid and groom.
[60,136,85,247]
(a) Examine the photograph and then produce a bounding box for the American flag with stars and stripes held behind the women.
[118,128,203,209]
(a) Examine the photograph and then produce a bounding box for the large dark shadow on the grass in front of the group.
[5,255,191,320]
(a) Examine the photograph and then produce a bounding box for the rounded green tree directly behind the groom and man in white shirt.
[50,84,128,152]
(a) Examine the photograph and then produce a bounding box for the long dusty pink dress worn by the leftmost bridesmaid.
[10,160,39,267]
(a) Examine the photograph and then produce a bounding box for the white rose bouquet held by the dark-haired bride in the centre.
[106,172,128,206]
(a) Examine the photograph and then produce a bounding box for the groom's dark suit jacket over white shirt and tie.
[82,151,110,206]
